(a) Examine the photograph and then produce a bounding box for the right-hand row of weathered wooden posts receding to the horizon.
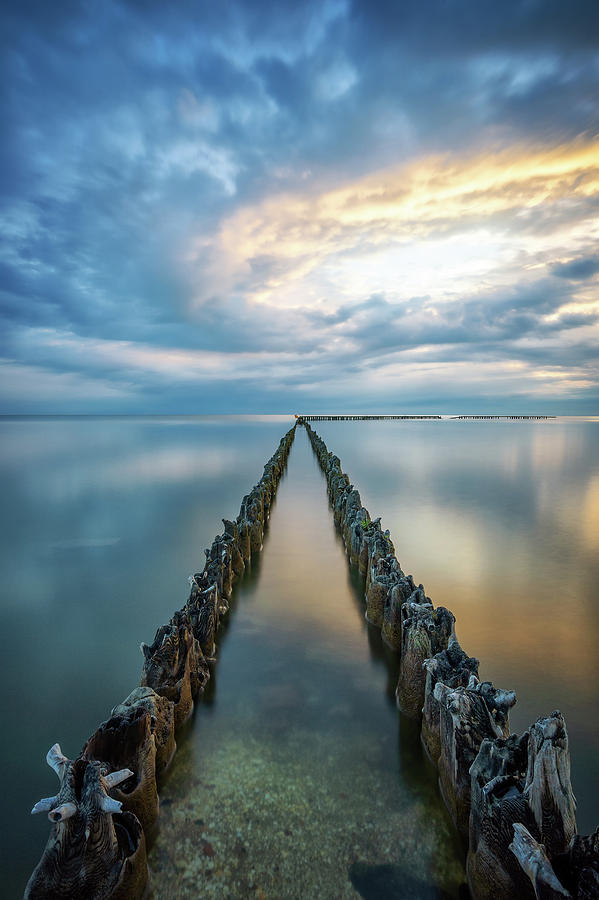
[300,419,599,900]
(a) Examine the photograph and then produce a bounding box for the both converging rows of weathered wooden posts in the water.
[25,417,599,900]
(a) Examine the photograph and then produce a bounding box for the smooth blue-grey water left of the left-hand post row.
[0,417,296,897]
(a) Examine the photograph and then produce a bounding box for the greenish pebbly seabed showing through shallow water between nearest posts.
[149,722,464,900]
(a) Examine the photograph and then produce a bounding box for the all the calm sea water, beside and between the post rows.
[0,417,599,897]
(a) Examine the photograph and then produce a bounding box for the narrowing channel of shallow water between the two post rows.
[150,430,464,900]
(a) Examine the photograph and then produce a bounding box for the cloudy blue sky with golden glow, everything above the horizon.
[0,0,599,415]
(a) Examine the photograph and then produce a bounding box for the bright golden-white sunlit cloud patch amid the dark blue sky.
[193,140,599,308]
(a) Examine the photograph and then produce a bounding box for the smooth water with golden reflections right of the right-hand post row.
[317,420,599,832]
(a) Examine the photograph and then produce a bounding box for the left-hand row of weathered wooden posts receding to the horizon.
[25,427,295,900]
